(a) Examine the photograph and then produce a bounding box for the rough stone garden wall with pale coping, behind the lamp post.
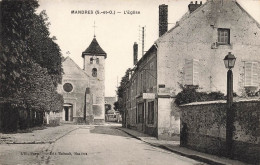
[181,101,260,164]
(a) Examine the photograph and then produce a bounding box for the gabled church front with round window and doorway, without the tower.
[58,57,92,122]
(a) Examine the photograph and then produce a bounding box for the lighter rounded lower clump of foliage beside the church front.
[16,63,63,112]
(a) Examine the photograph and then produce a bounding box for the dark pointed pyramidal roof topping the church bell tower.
[82,37,107,58]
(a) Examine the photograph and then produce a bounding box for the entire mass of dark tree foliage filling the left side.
[0,0,63,131]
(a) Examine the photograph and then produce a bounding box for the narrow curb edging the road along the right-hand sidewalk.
[116,128,226,165]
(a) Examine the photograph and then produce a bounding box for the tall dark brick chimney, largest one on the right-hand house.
[159,4,168,37]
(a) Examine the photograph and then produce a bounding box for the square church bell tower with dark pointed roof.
[82,36,107,123]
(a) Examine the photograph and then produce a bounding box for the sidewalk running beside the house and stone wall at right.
[117,127,249,165]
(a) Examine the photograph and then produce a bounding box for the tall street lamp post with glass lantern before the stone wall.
[224,52,236,157]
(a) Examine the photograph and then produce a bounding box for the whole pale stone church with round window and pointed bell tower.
[58,36,107,124]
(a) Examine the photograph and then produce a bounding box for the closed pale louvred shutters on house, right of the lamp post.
[245,62,259,87]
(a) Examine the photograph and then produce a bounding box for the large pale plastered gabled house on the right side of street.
[123,0,260,139]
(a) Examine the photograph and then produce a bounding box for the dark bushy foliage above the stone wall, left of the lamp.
[175,85,225,105]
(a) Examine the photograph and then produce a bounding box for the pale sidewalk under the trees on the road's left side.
[0,124,90,144]
